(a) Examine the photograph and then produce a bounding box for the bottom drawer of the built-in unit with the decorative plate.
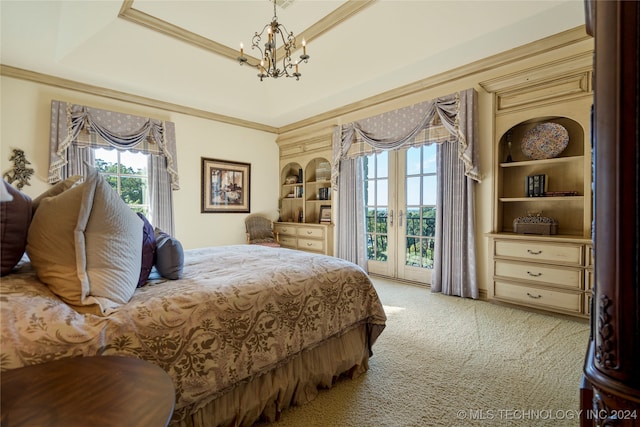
[493,280,582,313]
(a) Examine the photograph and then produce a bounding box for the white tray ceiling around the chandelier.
[0,0,584,127]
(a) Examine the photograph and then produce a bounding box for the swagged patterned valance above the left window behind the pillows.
[48,100,180,190]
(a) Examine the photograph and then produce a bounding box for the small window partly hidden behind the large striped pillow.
[94,148,150,218]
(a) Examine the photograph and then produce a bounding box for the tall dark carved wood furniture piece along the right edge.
[581,0,640,426]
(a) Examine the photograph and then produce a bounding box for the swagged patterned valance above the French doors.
[331,89,480,187]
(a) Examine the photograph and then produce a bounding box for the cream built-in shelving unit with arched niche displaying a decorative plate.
[481,54,593,317]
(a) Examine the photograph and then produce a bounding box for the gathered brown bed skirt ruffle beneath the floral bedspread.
[175,324,377,427]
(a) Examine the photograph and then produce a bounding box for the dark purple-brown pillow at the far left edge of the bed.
[0,179,31,276]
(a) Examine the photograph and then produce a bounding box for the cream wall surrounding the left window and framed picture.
[0,76,278,248]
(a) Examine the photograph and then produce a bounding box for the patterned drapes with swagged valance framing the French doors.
[331,89,480,298]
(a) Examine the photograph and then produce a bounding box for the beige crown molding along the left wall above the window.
[0,64,278,133]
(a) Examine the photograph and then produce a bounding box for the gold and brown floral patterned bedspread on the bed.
[0,245,386,419]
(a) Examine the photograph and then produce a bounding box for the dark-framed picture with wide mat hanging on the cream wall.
[200,157,251,213]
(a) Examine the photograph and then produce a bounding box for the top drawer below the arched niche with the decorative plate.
[494,240,584,266]
